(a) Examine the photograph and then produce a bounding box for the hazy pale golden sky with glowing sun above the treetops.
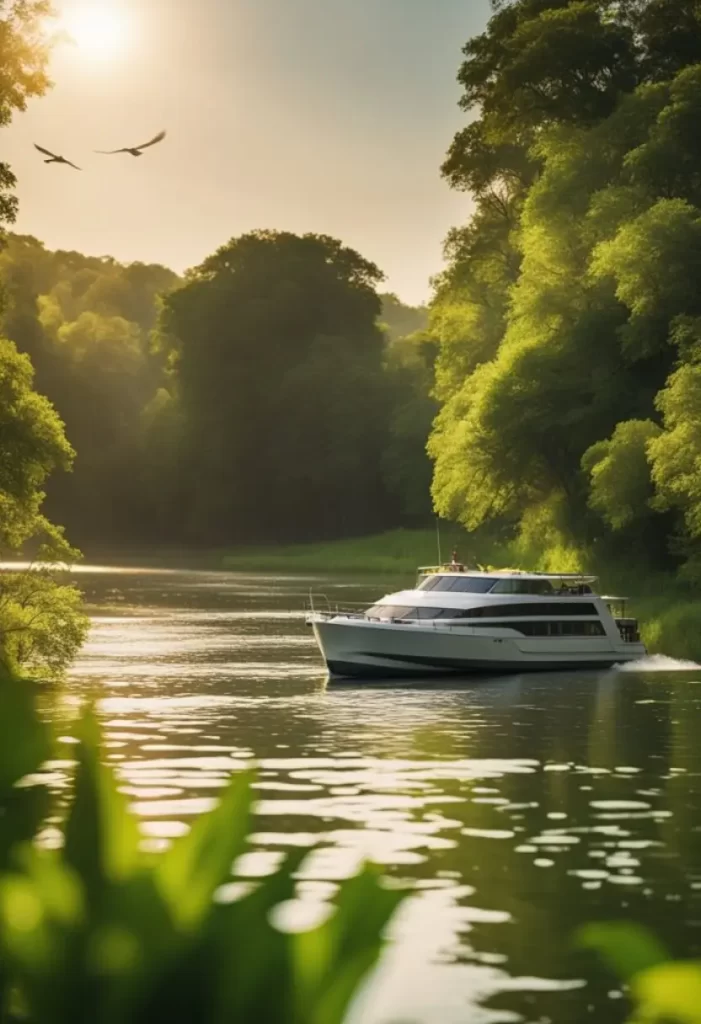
[3,0,488,302]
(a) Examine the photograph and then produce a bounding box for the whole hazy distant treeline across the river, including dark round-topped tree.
[0,231,435,547]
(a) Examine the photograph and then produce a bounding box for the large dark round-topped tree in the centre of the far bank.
[162,231,399,543]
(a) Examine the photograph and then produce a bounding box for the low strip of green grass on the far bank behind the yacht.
[221,526,470,574]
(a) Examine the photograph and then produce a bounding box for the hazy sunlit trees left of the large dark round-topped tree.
[0,236,178,545]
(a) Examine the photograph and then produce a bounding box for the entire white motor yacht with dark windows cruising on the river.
[307,565,647,679]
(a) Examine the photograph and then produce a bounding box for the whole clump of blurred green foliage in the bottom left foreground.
[0,682,401,1024]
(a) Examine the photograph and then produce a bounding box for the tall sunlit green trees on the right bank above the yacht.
[431,0,701,578]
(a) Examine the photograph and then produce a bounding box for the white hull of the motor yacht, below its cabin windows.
[311,616,646,679]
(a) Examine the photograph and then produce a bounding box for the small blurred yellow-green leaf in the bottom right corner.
[630,963,701,1024]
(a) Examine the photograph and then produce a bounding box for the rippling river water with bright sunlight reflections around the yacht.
[54,567,701,1024]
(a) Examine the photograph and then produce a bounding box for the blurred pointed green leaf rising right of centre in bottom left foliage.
[158,772,254,928]
